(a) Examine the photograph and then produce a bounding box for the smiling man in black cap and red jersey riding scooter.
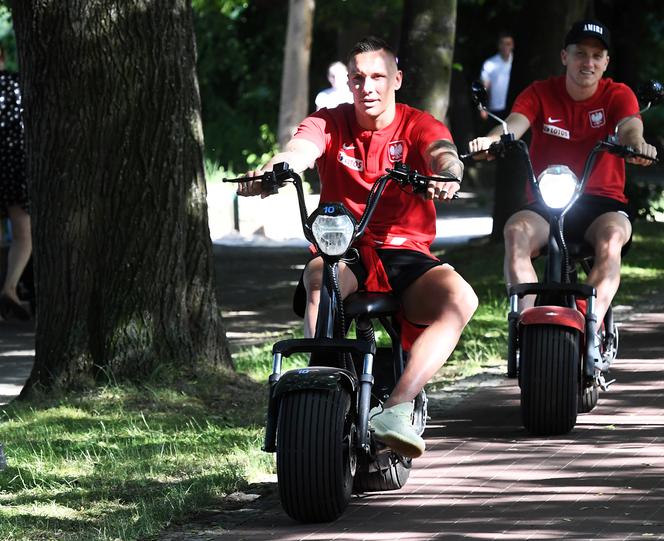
[469,20,657,360]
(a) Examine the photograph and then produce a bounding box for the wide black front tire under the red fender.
[519,325,581,436]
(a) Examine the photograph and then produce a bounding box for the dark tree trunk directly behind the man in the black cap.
[491,0,588,242]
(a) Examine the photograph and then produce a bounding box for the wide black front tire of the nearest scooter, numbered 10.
[277,388,355,522]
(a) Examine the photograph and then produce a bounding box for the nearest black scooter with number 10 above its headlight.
[224,163,459,522]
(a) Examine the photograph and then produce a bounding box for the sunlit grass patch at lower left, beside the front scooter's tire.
[0,374,273,541]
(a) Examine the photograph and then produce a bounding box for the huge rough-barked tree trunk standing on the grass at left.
[12,0,230,389]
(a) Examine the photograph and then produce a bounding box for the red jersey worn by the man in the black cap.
[512,75,639,203]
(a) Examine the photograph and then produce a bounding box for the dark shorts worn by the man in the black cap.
[522,195,634,254]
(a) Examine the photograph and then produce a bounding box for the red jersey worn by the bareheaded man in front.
[295,103,452,253]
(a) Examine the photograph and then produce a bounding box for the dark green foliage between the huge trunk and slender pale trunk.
[193,0,287,171]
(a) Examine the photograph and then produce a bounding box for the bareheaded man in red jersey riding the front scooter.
[238,38,478,458]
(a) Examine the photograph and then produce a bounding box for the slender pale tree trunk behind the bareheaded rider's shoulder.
[278,0,315,148]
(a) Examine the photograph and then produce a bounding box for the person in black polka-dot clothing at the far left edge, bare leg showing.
[0,48,32,320]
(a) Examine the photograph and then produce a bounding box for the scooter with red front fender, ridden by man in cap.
[462,81,664,435]
